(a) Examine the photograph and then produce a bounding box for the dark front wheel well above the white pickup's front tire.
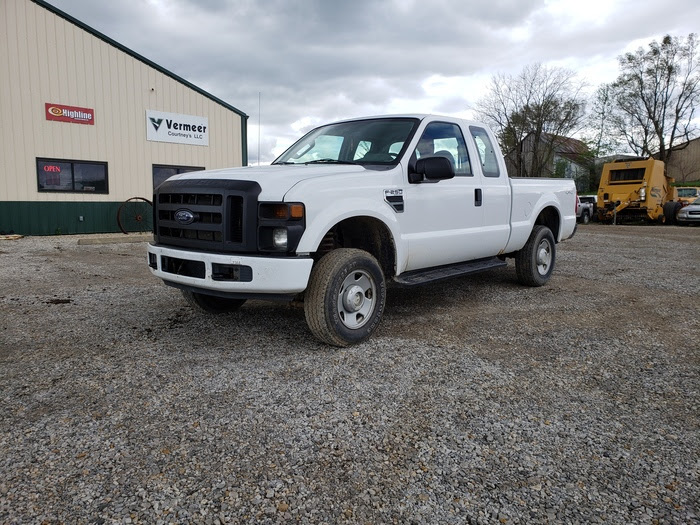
[312,217,396,276]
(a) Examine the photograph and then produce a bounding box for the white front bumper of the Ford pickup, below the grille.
[147,244,313,298]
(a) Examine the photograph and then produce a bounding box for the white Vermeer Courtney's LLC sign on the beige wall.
[146,109,209,146]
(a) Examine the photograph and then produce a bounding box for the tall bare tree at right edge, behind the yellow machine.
[610,33,700,162]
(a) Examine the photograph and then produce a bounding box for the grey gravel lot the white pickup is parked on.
[0,224,700,524]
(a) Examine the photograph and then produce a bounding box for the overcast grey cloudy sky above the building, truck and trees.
[49,0,700,164]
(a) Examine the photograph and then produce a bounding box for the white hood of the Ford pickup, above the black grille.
[168,164,369,201]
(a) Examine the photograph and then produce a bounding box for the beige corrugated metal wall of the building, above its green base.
[0,0,246,232]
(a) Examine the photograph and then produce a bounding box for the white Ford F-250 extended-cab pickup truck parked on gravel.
[148,115,576,346]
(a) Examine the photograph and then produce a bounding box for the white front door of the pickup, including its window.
[400,121,505,270]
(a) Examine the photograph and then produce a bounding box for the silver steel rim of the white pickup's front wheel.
[337,270,377,330]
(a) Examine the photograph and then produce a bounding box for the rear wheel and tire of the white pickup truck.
[515,225,557,286]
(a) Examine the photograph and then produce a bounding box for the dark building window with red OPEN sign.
[36,158,109,193]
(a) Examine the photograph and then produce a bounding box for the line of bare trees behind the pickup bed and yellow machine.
[475,33,700,186]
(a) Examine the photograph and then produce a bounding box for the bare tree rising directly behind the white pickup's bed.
[476,64,585,177]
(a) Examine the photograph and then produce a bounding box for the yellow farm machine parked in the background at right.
[598,159,682,224]
